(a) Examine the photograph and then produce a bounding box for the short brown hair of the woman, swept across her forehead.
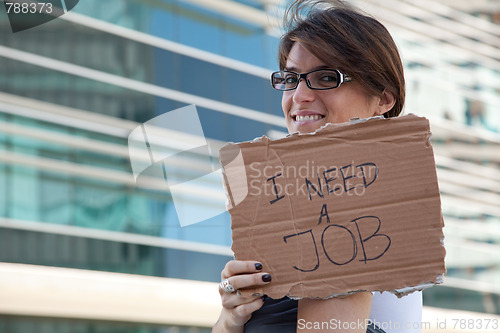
[278,0,405,117]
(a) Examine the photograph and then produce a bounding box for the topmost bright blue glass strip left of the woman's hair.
[69,0,282,68]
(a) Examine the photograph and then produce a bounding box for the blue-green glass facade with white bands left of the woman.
[0,1,282,333]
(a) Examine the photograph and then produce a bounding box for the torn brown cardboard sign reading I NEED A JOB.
[220,115,445,298]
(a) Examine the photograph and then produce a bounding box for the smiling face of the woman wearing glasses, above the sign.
[281,42,388,133]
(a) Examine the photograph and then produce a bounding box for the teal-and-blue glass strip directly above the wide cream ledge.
[0,228,232,282]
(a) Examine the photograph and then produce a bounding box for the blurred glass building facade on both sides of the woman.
[0,0,500,333]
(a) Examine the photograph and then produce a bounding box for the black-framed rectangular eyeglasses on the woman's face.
[271,69,352,91]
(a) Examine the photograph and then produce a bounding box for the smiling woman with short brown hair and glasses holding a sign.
[213,0,421,333]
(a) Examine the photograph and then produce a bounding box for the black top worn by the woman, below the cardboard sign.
[245,297,385,333]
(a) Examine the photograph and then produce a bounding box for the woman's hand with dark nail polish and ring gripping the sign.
[212,260,271,333]
